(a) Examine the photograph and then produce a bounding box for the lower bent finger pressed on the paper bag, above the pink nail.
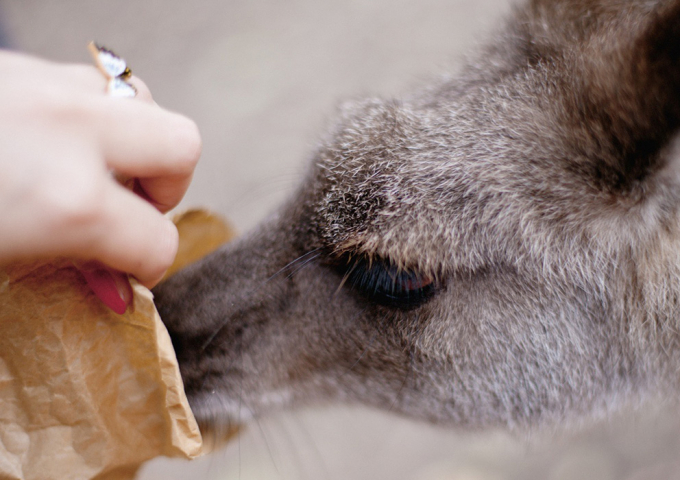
[74,182,178,288]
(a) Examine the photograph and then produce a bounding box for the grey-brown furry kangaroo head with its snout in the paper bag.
[155,0,680,436]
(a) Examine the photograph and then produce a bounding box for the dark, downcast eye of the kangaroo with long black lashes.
[344,259,436,310]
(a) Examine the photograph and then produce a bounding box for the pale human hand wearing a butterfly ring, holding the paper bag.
[0,51,201,312]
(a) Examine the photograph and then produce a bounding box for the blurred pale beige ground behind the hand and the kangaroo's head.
[0,0,680,480]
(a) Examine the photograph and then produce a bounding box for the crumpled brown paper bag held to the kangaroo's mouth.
[0,212,236,480]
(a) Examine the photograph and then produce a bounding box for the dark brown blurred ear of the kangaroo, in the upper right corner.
[568,1,680,191]
